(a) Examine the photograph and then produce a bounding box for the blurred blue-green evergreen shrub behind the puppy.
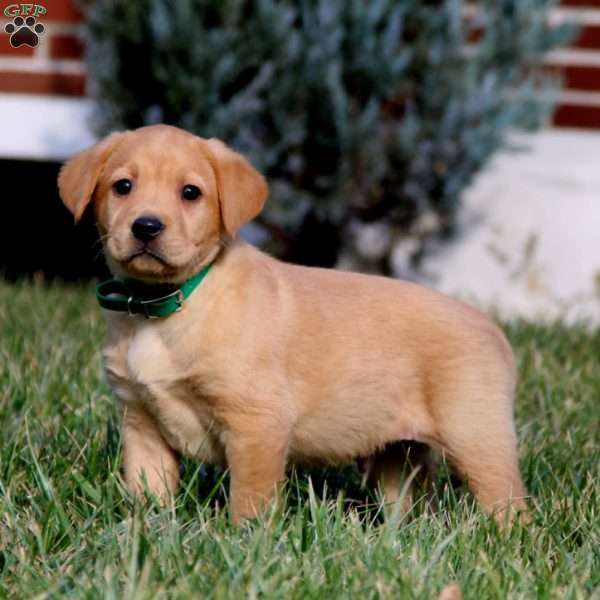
[87,0,569,272]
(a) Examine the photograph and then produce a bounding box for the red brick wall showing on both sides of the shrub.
[0,0,600,129]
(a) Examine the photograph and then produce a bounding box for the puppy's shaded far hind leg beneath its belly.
[365,441,432,516]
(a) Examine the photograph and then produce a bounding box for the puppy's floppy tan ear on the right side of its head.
[206,138,269,237]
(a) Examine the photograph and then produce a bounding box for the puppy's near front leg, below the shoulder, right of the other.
[227,427,289,524]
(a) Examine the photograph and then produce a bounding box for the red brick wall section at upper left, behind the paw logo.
[0,0,86,97]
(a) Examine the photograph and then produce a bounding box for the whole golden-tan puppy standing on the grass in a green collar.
[58,125,525,522]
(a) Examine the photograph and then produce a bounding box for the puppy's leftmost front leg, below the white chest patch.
[122,405,179,502]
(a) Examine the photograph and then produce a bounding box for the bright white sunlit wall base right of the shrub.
[420,129,600,325]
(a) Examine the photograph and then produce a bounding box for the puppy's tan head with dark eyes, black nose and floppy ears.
[58,125,268,282]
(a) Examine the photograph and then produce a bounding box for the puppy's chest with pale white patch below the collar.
[105,323,224,464]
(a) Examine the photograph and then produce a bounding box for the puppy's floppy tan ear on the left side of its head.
[58,133,125,223]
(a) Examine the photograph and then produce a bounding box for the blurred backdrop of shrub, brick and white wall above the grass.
[0,0,600,323]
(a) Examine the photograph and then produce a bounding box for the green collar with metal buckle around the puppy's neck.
[96,263,212,319]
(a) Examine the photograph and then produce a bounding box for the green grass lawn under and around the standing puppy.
[0,283,600,599]
